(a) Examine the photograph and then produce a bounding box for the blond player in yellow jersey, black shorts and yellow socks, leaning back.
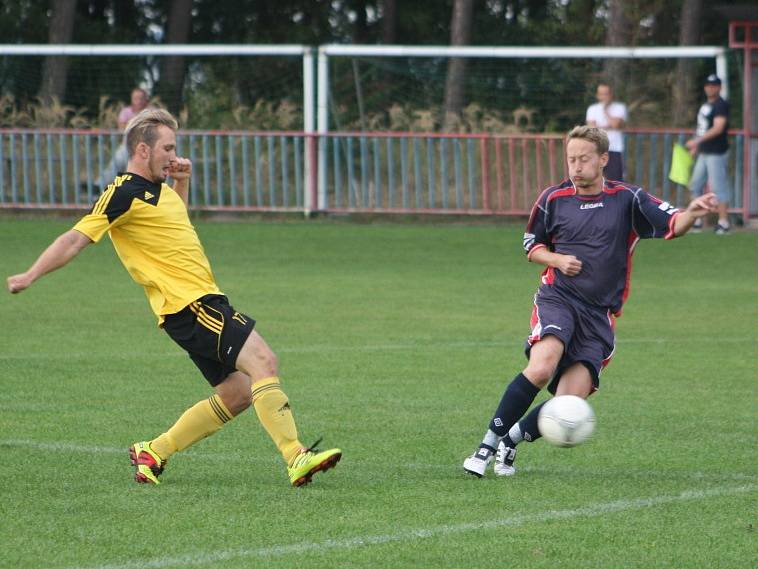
[8,109,342,486]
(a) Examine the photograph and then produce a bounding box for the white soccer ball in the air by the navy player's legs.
[537,395,595,447]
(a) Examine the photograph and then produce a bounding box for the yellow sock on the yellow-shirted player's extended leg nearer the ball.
[254,377,303,465]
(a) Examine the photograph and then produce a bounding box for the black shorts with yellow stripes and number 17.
[163,294,255,386]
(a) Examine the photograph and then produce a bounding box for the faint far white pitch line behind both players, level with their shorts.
[0,337,758,361]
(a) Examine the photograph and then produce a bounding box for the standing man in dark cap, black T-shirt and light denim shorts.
[687,75,730,235]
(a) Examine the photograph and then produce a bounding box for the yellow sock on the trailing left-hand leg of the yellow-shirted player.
[150,394,232,460]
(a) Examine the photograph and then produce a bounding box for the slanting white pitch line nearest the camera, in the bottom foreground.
[62,484,758,569]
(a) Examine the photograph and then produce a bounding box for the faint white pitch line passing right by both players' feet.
[0,439,758,482]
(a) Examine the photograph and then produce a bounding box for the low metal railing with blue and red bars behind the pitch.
[0,129,756,218]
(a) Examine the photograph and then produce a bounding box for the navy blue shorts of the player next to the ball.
[525,285,616,393]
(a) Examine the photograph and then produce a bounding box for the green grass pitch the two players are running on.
[0,216,758,569]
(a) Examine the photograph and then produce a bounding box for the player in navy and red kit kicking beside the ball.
[463,126,716,477]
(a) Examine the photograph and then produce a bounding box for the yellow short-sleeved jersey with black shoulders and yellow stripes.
[74,173,221,325]
